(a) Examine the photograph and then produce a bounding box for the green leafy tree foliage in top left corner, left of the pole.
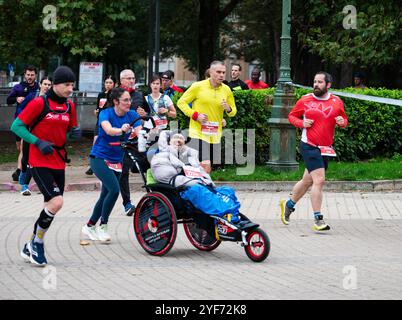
[0,0,149,75]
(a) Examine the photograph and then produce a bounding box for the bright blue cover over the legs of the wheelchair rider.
[180,184,240,220]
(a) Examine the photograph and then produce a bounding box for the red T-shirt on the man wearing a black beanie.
[18,97,77,170]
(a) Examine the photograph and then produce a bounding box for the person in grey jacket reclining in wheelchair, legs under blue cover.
[151,131,240,223]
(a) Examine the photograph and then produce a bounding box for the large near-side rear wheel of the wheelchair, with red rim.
[134,192,177,256]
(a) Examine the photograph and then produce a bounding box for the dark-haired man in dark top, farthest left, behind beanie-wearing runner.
[7,65,39,181]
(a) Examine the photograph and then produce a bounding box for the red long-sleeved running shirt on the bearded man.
[288,93,348,146]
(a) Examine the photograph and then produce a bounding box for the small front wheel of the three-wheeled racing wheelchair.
[244,228,271,262]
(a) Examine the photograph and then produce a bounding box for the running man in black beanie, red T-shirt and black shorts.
[11,66,81,266]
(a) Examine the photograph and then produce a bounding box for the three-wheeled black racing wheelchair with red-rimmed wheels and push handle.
[121,117,271,262]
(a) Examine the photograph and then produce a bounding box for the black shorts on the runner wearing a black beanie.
[31,168,66,202]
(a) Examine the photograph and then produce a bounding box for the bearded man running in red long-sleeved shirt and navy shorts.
[280,71,348,231]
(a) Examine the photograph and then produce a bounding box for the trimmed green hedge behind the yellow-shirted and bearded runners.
[173,88,402,164]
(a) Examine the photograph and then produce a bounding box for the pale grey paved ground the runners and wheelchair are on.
[0,192,402,300]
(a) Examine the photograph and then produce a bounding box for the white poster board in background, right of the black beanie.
[79,62,103,97]
